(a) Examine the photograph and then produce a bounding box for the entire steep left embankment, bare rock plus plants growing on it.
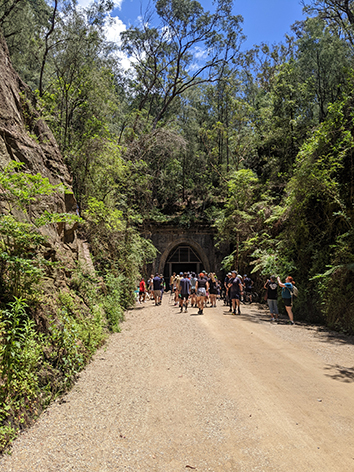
[0,33,103,454]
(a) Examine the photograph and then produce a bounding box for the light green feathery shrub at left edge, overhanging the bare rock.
[0,161,81,300]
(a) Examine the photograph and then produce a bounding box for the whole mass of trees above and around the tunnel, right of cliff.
[0,0,354,331]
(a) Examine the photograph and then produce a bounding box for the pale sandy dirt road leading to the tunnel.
[0,296,354,472]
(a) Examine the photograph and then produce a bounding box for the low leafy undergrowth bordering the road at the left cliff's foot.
[0,276,108,451]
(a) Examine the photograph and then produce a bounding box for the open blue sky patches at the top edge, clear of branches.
[109,0,304,48]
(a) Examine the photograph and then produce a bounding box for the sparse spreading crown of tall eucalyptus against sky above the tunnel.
[123,0,243,128]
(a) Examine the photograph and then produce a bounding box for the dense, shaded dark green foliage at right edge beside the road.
[262,83,354,322]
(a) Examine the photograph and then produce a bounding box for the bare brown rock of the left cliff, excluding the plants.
[0,35,93,296]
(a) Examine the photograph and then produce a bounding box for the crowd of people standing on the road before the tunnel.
[138,270,297,324]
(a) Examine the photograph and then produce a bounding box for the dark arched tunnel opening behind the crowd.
[164,245,204,285]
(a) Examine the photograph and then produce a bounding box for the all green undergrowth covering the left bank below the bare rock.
[0,163,134,452]
